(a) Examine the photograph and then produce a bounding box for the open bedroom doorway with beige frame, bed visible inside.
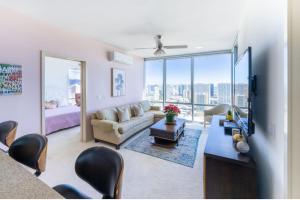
[41,52,86,142]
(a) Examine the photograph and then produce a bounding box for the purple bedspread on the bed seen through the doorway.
[45,106,80,135]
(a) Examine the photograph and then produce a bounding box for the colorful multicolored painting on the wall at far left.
[0,64,22,95]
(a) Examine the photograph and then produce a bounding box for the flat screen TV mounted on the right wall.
[233,47,255,137]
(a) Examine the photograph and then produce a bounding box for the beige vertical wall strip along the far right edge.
[288,0,300,198]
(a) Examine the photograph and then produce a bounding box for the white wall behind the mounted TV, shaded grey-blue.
[238,0,286,198]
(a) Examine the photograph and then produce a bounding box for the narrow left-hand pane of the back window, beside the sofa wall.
[144,60,163,103]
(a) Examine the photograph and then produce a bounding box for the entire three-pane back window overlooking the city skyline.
[145,52,231,122]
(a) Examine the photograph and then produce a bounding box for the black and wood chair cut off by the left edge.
[0,121,18,147]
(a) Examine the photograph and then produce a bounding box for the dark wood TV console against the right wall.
[203,115,257,199]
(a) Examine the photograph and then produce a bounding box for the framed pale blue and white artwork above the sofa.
[112,69,126,97]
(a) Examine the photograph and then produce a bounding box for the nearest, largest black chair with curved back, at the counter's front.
[53,147,124,199]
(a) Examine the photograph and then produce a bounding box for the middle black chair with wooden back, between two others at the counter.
[8,134,48,176]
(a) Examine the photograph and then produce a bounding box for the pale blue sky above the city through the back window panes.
[145,54,231,84]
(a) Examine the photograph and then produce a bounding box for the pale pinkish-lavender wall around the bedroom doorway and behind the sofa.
[0,6,144,139]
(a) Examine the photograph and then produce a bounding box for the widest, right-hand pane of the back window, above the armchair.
[194,54,231,121]
